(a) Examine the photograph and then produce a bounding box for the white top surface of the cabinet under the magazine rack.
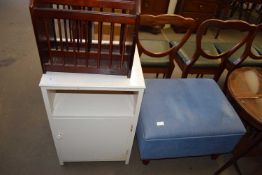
[39,49,145,90]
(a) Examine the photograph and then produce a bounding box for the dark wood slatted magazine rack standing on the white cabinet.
[30,0,140,76]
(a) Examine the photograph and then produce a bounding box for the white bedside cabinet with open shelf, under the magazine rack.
[39,48,145,165]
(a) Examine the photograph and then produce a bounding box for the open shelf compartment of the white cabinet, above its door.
[48,90,138,117]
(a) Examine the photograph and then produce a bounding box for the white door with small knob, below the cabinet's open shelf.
[53,117,131,162]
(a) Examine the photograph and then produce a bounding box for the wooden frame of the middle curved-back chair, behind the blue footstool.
[176,19,255,81]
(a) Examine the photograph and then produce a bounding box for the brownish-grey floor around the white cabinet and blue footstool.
[0,0,262,175]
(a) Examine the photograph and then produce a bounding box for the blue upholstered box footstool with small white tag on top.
[137,79,246,160]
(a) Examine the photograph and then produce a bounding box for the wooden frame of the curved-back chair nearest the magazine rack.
[137,14,195,78]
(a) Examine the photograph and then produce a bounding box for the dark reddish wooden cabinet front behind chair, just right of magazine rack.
[141,0,169,15]
